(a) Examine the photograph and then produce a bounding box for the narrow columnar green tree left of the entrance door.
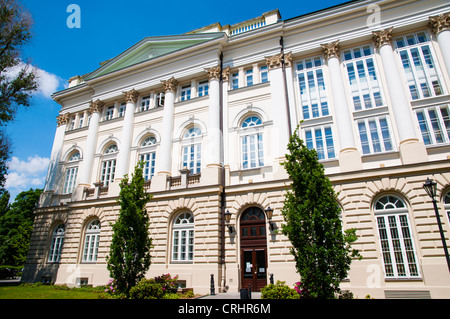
[107,163,152,295]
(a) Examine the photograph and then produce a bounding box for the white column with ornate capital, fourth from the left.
[151,77,178,191]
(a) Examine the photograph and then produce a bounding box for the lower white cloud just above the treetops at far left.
[5,155,50,199]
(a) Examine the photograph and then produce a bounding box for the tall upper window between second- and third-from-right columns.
[343,45,383,111]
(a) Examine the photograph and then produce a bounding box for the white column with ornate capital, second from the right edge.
[373,28,428,164]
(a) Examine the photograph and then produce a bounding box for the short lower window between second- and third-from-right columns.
[357,116,393,154]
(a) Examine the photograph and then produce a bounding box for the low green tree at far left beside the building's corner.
[0,189,42,266]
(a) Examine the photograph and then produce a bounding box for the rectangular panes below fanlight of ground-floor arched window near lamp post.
[377,214,419,278]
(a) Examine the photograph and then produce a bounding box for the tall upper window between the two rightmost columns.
[394,32,444,100]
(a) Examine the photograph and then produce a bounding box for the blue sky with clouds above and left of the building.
[6,0,346,198]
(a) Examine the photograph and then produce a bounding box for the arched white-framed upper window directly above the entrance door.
[240,115,264,169]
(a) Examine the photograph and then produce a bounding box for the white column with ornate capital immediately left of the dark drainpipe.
[202,65,222,185]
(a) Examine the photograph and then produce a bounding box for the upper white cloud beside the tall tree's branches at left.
[6,61,67,98]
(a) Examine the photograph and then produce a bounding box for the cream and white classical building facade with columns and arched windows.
[23,0,450,298]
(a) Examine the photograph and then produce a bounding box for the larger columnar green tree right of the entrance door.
[282,128,359,299]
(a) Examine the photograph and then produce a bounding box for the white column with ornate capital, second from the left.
[76,100,104,195]
